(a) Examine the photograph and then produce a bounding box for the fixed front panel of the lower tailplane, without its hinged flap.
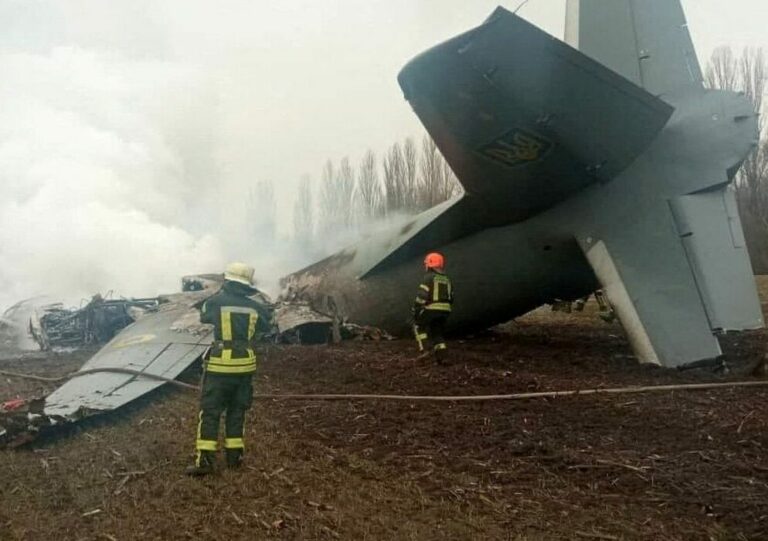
[577,201,722,366]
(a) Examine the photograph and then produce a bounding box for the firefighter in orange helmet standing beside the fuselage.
[412,252,453,364]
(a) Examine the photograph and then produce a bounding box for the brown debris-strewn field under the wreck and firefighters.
[0,288,768,540]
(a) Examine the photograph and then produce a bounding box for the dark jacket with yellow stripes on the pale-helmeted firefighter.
[200,280,270,374]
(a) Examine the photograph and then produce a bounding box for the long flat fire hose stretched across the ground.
[0,368,768,402]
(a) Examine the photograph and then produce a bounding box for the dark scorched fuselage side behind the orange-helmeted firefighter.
[281,215,600,336]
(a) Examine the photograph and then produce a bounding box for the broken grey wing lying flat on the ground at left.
[44,290,215,421]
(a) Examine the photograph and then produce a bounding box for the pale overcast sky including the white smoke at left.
[0,0,768,308]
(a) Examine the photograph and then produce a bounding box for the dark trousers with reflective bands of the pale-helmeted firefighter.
[195,372,253,465]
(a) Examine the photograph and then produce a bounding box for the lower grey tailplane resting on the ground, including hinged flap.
[577,186,763,366]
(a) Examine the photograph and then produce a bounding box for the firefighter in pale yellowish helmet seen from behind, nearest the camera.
[187,263,270,475]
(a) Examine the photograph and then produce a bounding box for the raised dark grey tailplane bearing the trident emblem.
[398,8,673,223]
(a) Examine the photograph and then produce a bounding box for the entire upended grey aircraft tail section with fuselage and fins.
[283,0,763,366]
